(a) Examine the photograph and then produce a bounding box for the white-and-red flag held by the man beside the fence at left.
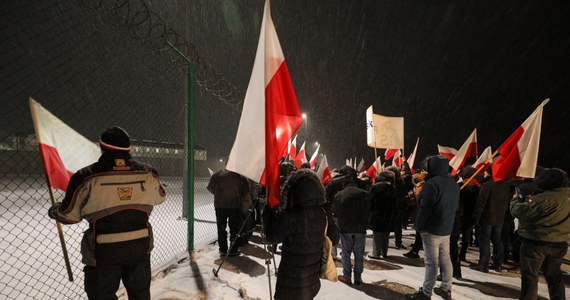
[29,98,101,191]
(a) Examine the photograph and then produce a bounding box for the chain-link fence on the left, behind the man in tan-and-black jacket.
[0,0,243,299]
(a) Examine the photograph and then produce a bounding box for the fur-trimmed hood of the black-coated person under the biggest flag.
[278,169,326,211]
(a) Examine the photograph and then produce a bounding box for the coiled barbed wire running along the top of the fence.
[77,0,243,111]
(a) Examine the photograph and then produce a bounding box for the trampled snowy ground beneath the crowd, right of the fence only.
[144,230,570,300]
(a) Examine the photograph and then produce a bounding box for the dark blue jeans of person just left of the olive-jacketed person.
[479,224,504,269]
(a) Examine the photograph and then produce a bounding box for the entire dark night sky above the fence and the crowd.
[0,0,570,176]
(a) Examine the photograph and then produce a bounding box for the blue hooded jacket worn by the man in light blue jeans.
[416,155,459,236]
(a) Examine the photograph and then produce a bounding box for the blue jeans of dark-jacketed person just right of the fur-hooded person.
[340,233,366,280]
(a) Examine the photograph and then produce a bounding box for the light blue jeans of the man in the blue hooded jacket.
[421,232,453,296]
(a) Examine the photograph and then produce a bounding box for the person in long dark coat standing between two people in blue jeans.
[368,171,398,259]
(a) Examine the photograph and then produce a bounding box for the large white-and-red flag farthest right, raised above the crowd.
[492,99,550,181]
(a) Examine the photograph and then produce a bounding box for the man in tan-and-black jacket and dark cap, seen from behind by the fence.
[48,127,165,300]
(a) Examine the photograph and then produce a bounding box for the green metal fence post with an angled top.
[167,42,196,253]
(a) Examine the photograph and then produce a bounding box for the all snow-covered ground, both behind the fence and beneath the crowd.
[0,177,570,300]
